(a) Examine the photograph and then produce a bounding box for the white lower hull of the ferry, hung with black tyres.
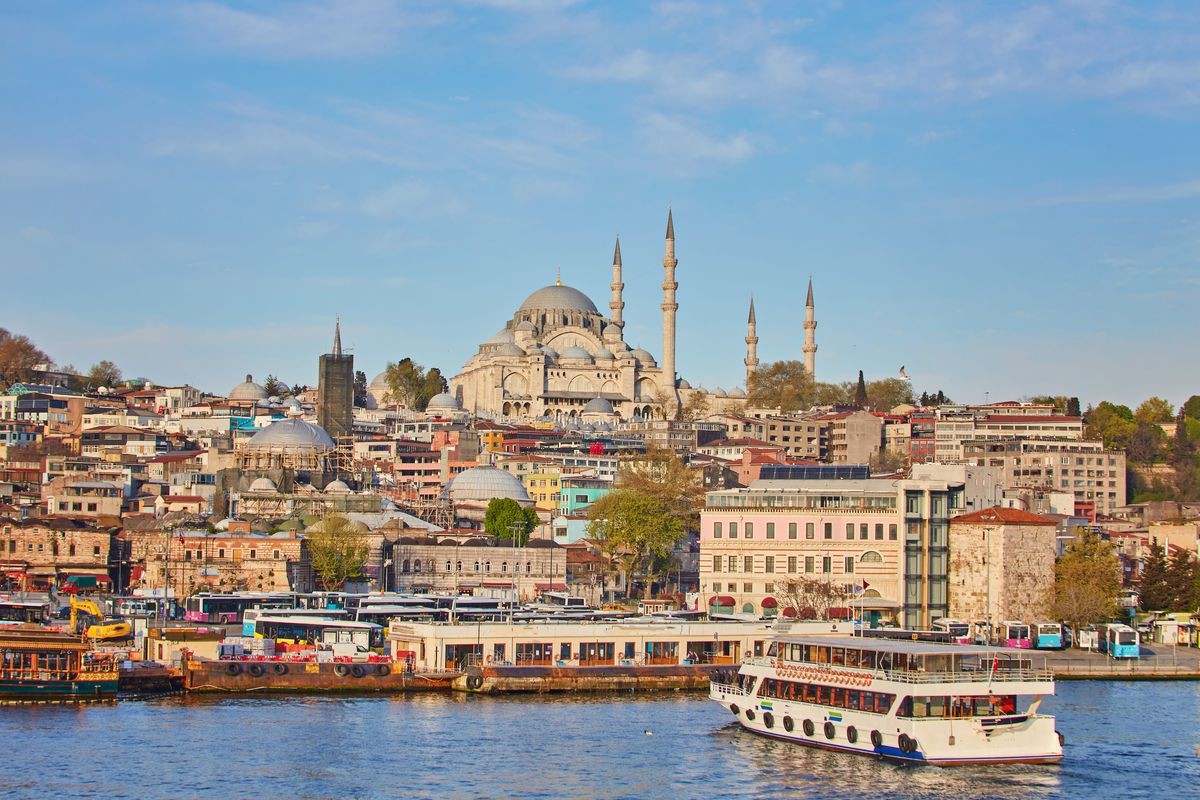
[709,686,1062,766]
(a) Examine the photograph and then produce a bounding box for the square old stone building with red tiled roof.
[949,507,1056,625]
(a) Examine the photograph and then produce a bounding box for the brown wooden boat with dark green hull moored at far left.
[0,625,119,703]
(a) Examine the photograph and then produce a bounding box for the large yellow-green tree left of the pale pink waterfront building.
[588,488,686,597]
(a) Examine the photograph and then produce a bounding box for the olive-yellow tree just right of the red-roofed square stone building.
[1050,531,1121,639]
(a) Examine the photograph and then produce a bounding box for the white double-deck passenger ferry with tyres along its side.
[709,634,1062,766]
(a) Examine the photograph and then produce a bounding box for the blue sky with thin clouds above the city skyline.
[0,0,1200,404]
